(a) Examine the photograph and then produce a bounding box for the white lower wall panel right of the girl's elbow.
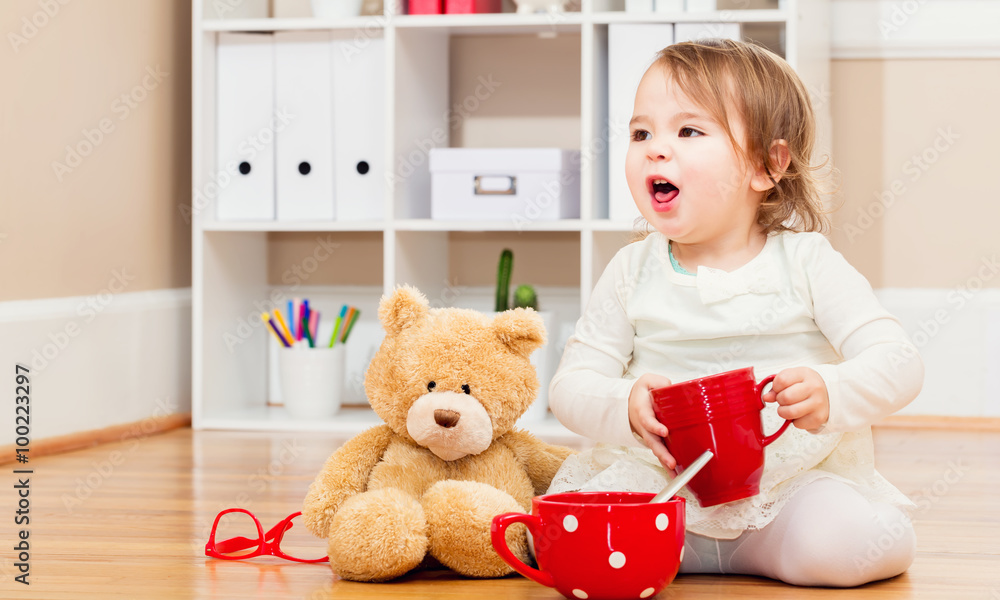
[877,288,1000,417]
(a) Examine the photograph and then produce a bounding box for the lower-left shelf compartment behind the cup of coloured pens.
[194,231,384,428]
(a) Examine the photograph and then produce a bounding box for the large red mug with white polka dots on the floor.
[490,492,684,600]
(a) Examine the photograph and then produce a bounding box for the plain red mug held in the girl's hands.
[651,367,791,506]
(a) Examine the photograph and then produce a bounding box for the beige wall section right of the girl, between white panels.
[831,59,1000,288]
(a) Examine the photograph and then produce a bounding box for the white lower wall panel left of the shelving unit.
[0,288,191,444]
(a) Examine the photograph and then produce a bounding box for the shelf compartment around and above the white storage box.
[391,28,581,220]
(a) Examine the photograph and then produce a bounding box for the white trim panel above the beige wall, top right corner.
[832,0,1000,59]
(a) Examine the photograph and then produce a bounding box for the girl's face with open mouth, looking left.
[625,65,762,244]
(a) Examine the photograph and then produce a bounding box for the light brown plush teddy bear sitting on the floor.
[302,286,573,582]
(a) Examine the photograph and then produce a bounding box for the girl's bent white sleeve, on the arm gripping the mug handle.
[802,234,924,433]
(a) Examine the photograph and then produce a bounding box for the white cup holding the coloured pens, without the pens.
[278,344,344,419]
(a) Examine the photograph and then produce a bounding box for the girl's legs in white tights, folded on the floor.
[680,479,916,587]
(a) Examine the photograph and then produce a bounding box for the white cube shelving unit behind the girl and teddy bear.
[192,0,830,432]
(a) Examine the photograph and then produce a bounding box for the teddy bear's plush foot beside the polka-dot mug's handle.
[422,480,529,577]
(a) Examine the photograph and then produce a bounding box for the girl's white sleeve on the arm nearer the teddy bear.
[549,249,643,446]
